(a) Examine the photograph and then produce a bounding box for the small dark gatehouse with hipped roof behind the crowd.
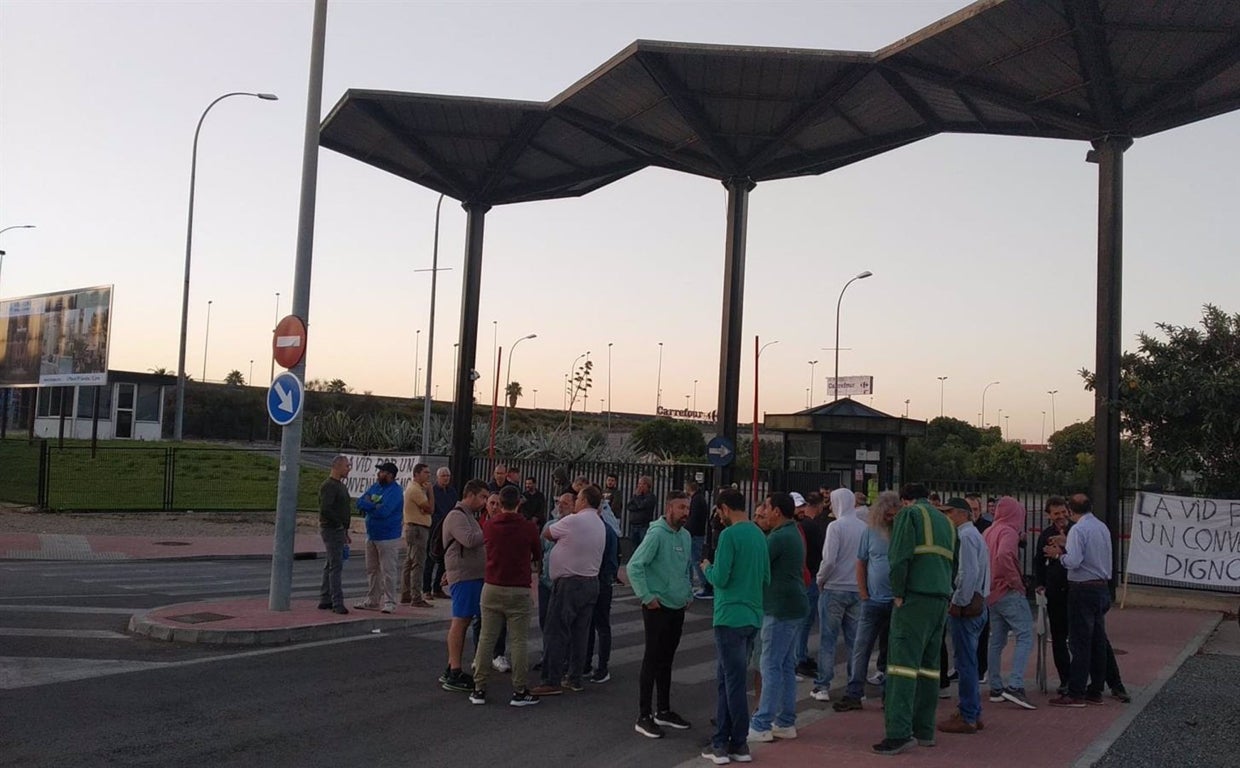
[763,397,926,496]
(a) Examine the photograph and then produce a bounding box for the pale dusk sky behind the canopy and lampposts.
[0,0,1240,442]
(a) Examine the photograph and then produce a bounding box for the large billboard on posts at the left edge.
[0,285,112,387]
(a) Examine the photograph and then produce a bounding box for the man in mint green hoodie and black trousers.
[629,491,693,738]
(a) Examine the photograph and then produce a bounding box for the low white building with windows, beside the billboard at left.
[35,371,176,440]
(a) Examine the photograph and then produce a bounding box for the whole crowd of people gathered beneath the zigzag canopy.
[320,457,1128,764]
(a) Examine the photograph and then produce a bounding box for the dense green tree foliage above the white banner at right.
[1081,304,1240,496]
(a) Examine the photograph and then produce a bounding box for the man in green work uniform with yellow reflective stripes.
[874,483,956,754]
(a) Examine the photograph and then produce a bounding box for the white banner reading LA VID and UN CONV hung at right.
[1128,493,1240,589]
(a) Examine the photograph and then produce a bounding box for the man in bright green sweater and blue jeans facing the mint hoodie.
[702,488,771,766]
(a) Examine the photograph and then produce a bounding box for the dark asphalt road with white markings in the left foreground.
[0,558,823,768]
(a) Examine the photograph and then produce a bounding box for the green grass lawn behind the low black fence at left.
[0,440,325,511]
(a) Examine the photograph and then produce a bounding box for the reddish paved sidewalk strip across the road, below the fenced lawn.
[0,534,322,561]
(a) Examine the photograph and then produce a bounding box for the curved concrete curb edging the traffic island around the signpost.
[128,603,448,646]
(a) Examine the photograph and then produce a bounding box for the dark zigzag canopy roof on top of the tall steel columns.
[321,0,1240,205]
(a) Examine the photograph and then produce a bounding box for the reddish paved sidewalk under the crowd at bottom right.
[709,608,1219,768]
